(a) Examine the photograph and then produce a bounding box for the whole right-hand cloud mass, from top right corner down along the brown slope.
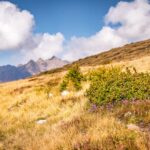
[63,0,150,60]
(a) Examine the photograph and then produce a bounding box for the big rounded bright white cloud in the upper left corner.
[0,1,34,50]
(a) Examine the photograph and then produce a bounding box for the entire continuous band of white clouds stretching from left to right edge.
[0,0,150,63]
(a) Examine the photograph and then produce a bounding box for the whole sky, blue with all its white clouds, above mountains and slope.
[0,0,150,65]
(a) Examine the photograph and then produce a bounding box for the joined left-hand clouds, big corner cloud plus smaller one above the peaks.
[0,1,64,63]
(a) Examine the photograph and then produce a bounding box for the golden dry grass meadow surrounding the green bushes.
[0,41,150,150]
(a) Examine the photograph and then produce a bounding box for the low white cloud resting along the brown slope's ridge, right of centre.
[63,26,127,61]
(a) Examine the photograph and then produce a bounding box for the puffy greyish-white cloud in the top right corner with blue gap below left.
[106,0,150,41]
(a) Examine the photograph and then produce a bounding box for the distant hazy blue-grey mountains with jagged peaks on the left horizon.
[0,56,69,82]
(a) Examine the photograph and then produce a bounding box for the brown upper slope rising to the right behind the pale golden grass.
[45,40,150,73]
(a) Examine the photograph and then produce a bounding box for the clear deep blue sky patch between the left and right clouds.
[11,0,127,39]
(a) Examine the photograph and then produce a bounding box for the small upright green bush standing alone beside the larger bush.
[60,64,84,91]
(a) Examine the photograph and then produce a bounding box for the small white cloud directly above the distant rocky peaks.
[22,33,64,61]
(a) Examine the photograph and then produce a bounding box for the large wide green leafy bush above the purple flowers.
[86,68,150,105]
